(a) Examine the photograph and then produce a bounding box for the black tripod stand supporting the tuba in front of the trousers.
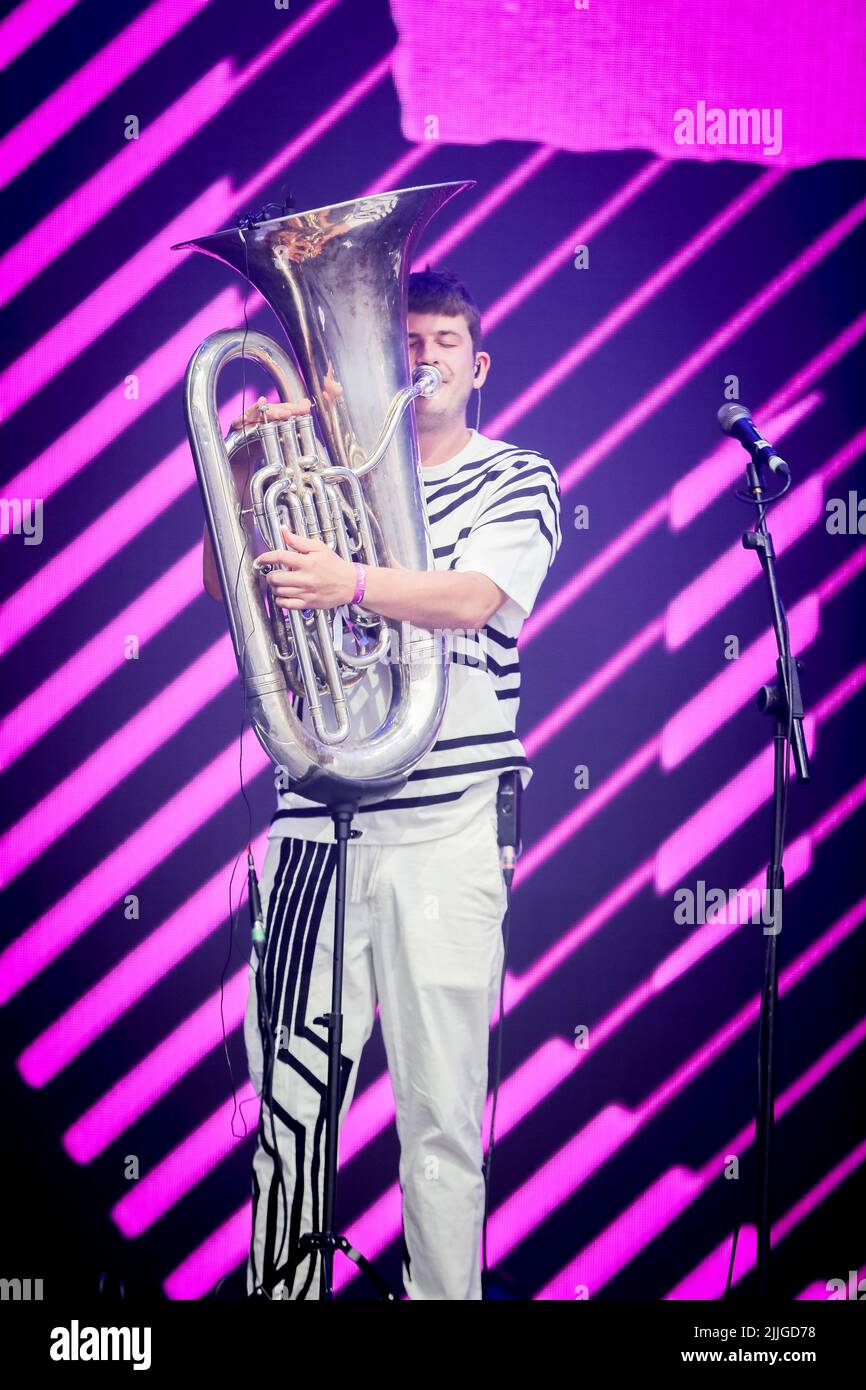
[261,802,396,1302]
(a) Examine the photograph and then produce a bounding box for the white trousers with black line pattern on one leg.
[245,802,506,1300]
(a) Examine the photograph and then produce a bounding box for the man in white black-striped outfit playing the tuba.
[204,270,562,1301]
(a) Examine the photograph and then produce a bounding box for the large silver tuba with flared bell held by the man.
[172,182,471,806]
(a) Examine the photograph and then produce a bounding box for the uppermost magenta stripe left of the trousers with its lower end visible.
[18,831,267,1089]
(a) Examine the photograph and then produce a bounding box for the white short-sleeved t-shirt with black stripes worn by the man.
[268,430,562,845]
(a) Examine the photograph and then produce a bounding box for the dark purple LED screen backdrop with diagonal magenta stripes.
[0,0,866,1300]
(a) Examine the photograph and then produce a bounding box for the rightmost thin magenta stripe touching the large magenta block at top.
[488,170,784,436]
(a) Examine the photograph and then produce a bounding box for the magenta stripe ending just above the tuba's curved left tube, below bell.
[6,286,243,522]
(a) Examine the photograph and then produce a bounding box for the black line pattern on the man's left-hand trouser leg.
[253,837,353,1297]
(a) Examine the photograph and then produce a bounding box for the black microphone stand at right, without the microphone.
[737,460,812,1298]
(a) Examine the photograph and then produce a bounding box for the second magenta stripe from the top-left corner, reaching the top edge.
[0,0,210,188]
